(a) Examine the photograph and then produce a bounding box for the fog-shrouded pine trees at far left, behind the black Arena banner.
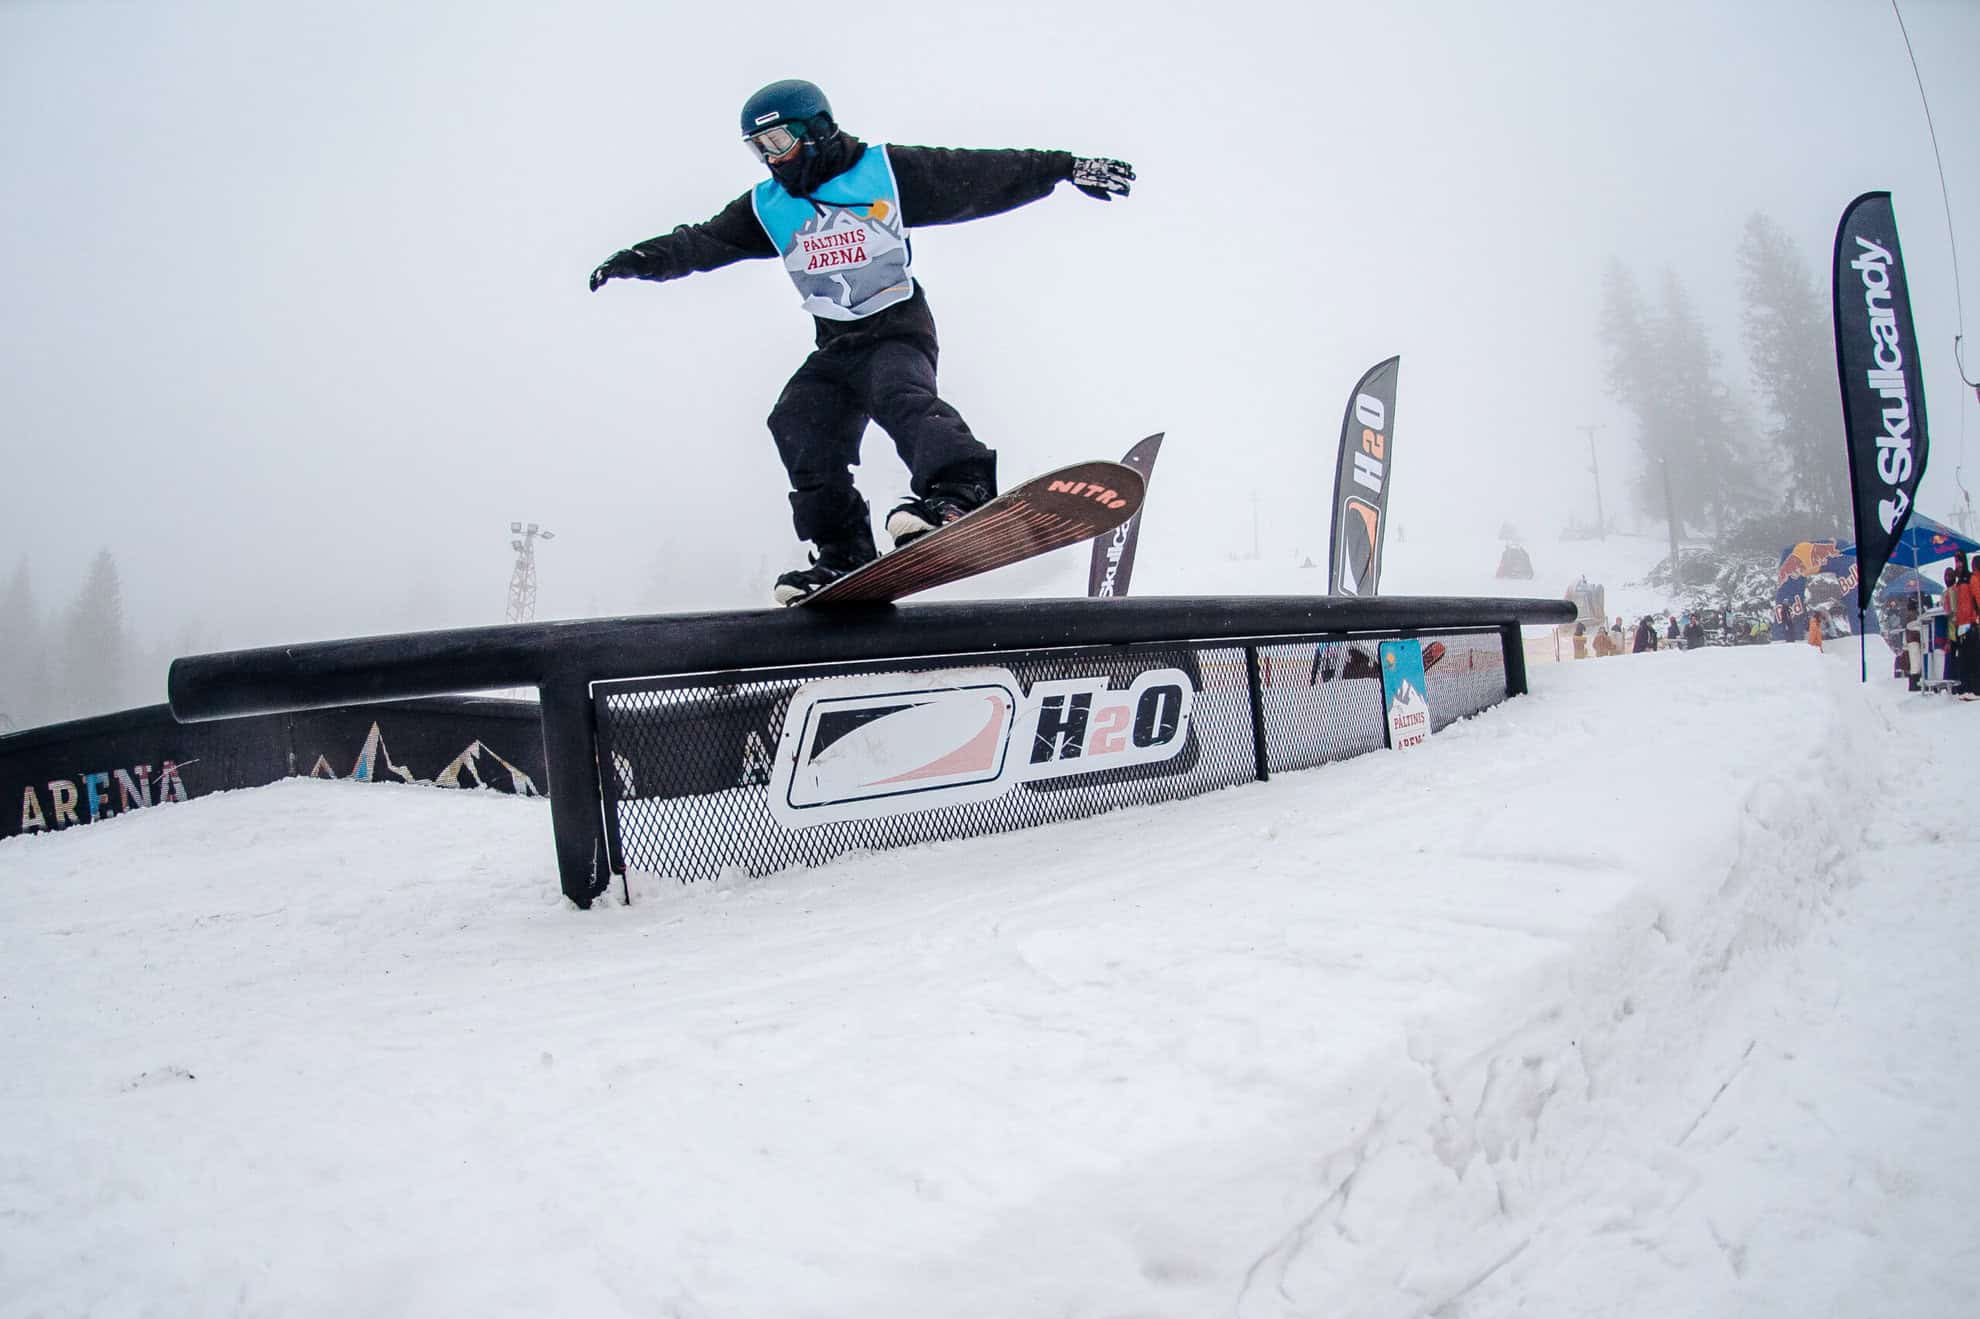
[0,551,164,733]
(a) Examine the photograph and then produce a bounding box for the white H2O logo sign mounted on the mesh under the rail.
[768,667,1196,828]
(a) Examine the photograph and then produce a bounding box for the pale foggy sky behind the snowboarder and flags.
[0,0,1980,648]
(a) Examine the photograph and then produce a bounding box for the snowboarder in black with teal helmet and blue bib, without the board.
[592,79,1135,604]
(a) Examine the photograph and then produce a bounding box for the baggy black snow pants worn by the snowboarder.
[770,335,996,545]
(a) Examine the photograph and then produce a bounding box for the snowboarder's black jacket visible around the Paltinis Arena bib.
[605,133,1073,347]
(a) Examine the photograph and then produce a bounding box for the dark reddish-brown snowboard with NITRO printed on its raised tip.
[796,461,1144,608]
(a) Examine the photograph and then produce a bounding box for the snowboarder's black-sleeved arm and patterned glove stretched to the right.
[887,147,1135,228]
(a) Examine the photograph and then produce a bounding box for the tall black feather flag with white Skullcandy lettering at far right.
[1835,192,1927,610]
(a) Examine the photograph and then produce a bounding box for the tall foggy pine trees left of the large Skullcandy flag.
[1600,214,1851,551]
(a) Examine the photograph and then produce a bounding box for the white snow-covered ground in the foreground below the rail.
[0,633,1980,1319]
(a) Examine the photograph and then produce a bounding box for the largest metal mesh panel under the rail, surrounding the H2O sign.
[592,646,1255,879]
